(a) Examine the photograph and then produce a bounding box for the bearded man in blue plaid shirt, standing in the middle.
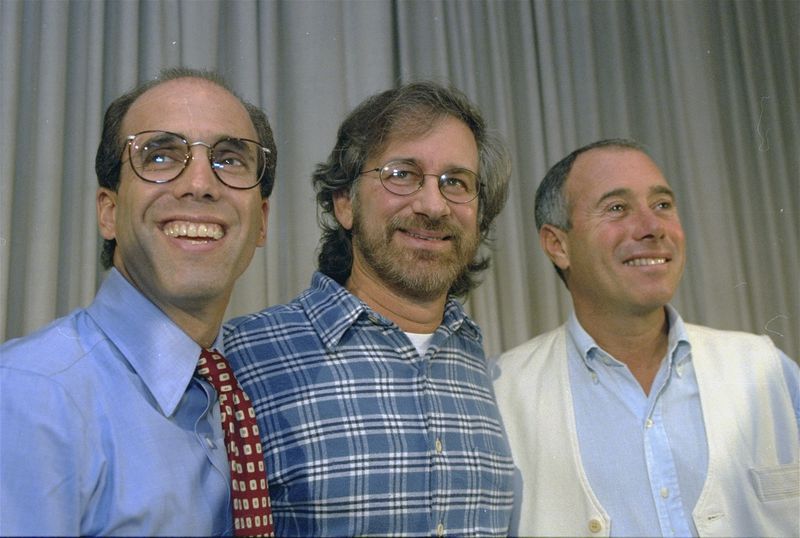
[225,83,513,536]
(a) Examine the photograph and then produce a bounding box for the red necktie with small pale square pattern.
[197,349,273,536]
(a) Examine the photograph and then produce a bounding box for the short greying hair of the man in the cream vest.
[534,138,649,284]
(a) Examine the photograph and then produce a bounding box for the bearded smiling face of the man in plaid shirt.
[334,116,479,300]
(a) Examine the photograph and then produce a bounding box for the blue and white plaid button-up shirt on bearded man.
[225,273,514,536]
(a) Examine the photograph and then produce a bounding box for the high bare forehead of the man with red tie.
[122,78,257,139]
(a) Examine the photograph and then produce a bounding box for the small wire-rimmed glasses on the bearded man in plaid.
[361,161,480,204]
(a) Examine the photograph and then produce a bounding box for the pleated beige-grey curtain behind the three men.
[0,0,800,359]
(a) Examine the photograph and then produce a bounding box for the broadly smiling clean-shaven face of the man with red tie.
[97,78,267,334]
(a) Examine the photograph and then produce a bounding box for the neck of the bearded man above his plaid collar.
[345,270,447,334]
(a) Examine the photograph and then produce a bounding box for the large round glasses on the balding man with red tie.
[126,131,270,189]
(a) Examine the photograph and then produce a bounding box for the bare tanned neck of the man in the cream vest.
[575,305,669,394]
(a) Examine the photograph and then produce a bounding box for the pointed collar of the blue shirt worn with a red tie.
[87,269,209,416]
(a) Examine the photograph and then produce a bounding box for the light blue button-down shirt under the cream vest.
[567,306,800,536]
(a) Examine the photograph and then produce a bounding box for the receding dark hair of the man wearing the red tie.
[94,67,278,269]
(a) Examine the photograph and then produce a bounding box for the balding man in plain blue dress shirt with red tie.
[0,69,275,536]
